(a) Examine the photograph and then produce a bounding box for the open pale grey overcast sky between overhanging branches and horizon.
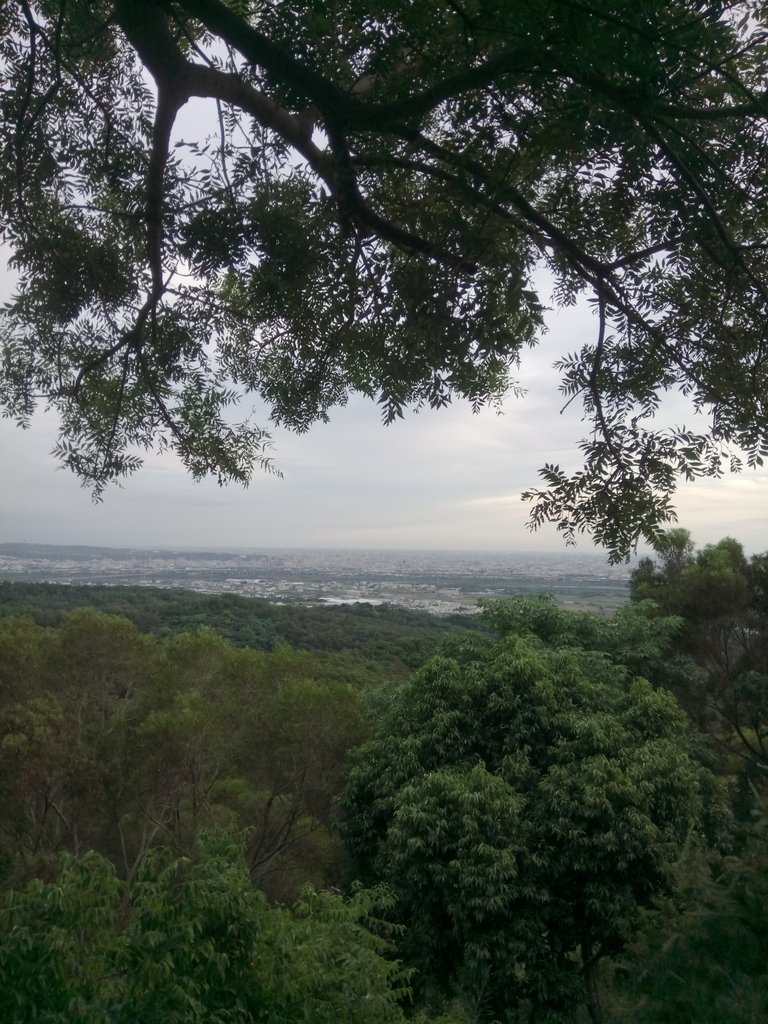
[0,244,768,552]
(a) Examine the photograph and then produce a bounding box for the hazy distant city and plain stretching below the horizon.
[0,542,630,613]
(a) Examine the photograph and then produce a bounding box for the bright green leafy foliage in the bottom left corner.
[0,835,408,1024]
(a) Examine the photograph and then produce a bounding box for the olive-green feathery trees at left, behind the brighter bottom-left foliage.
[0,610,365,899]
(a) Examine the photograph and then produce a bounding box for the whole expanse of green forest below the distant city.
[0,530,768,1024]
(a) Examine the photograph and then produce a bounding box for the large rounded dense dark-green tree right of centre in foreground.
[343,635,705,1020]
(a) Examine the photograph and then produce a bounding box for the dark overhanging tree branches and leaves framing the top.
[0,0,768,557]
